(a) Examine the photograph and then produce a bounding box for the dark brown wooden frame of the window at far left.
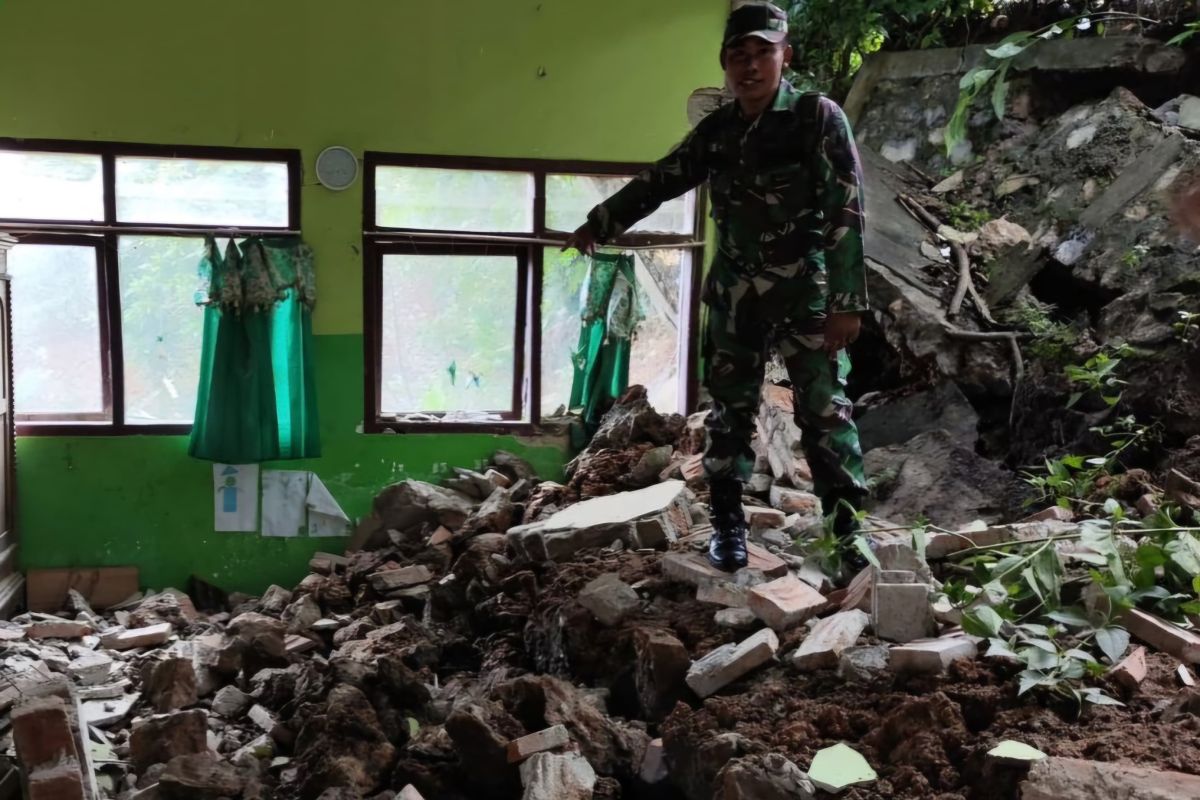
[0,137,304,437]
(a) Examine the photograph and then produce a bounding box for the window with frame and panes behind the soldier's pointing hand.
[364,152,703,432]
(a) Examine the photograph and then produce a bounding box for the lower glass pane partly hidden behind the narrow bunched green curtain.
[541,248,691,416]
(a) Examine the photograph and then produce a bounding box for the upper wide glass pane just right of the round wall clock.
[376,167,534,233]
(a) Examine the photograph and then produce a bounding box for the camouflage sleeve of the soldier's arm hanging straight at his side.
[816,97,869,314]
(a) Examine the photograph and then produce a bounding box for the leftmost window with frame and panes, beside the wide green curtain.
[0,140,300,434]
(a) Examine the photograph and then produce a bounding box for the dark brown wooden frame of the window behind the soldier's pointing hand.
[362,150,707,434]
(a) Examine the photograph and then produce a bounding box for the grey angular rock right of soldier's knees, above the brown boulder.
[854,380,979,455]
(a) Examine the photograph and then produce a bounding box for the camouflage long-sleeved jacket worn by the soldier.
[588,80,868,312]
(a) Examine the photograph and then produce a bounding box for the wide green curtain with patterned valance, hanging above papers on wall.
[187,236,320,464]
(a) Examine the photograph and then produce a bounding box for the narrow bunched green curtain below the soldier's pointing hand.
[570,253,643,435]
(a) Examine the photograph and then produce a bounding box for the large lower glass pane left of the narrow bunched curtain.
[379,254,517,415]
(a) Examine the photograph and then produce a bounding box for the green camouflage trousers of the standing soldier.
[703,268,866,513]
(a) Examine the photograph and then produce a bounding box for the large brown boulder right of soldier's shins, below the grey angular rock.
[865,431,1012,530]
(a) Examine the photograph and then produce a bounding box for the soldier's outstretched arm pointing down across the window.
[564,130,707,253]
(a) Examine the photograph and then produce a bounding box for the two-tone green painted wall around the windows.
[0,0,728,591]
